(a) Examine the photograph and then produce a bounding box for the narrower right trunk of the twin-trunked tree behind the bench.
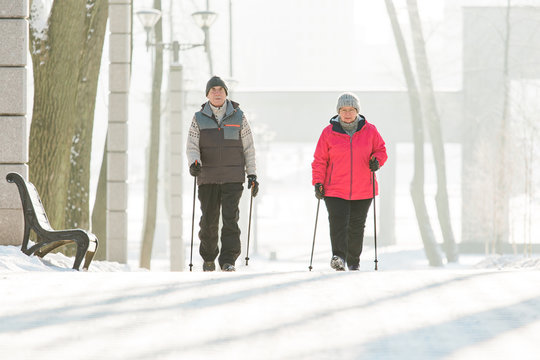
[66,0,109,229]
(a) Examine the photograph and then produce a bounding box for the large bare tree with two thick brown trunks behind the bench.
[29,0,108,239]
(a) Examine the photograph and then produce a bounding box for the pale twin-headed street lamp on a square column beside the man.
[137,9,217,271]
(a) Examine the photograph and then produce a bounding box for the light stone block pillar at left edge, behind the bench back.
[0,0,28,245]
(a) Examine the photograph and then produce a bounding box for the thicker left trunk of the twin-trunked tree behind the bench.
[28,1,87,229]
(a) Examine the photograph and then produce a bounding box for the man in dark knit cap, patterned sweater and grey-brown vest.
[187,76,259,271]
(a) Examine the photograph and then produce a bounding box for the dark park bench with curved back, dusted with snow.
[6,172,98,270]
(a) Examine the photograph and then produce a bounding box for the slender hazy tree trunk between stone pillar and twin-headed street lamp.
[140,0,163,269]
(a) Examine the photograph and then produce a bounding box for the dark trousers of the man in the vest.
[199,183,244,267]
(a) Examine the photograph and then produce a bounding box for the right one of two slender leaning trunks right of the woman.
[407,0,459,262]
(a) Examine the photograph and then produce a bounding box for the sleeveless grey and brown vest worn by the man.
[195,101,245,185]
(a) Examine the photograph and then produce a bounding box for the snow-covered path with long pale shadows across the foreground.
[0,267,540,360]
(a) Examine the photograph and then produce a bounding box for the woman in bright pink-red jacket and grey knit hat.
[311,93,388,271]
